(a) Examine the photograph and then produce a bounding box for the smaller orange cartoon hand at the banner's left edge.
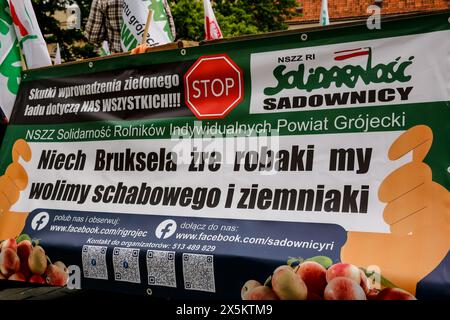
[0,139,31,240]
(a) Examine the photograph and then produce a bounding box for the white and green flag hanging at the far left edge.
[0,0,22,121]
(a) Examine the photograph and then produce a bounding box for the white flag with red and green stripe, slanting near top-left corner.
[9,0,52,69]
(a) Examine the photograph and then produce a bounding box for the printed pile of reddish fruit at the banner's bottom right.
[241,256,416,300]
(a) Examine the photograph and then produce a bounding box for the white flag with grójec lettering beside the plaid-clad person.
[121,0,174,51]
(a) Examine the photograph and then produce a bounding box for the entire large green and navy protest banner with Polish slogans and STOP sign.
[0,13,450,299]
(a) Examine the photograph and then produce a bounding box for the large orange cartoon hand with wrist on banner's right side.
[341,125,450,294]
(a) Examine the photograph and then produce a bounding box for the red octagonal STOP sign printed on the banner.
[184,54,244,119]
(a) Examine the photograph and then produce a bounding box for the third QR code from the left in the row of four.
[147,250,177,288]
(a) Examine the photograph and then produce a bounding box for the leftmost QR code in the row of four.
[81,245,108,280]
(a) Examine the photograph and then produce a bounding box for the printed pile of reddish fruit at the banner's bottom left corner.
[0,235,69,286]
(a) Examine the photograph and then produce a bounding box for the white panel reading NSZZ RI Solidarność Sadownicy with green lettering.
[250,30,450,113]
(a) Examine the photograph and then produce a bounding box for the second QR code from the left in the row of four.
[113,248,141,283]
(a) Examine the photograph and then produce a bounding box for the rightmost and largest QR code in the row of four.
[183,253,216,292]
